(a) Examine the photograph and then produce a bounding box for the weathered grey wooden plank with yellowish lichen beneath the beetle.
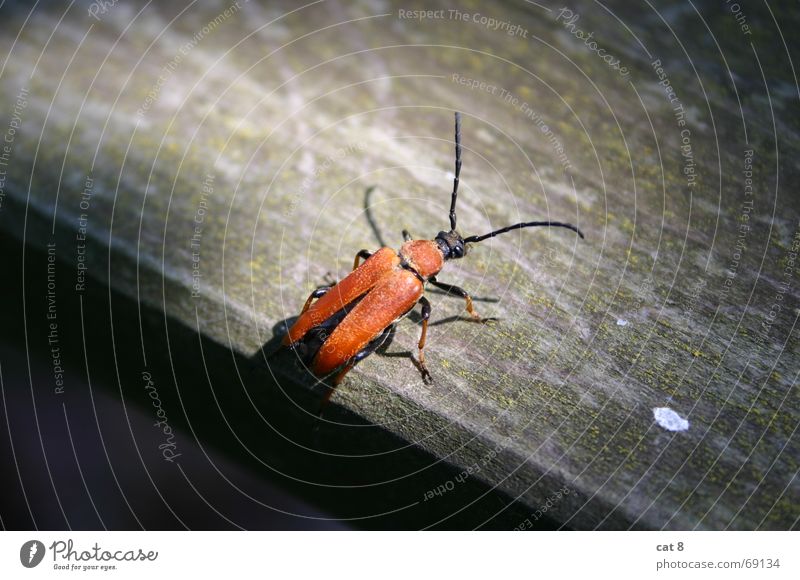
[0,2,800,529]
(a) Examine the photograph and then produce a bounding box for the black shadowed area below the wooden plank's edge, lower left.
[0,231,555,529]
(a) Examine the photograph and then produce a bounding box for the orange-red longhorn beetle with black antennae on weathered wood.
[282,112,584,401]
